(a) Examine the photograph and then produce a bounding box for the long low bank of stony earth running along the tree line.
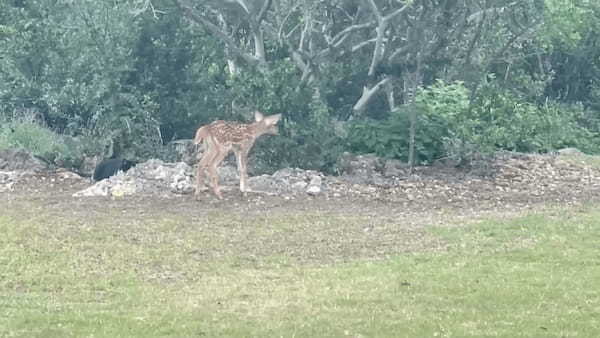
[0,147,600,209]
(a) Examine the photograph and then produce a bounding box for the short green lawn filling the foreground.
[0,206,600,337]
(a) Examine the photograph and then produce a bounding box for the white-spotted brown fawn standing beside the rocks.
[194,111,281,199]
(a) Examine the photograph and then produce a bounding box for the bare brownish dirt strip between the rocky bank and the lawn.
[0,152,600,264]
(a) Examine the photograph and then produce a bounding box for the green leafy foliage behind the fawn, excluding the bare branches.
[0,0,600,172]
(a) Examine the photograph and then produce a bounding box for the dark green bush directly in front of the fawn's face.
[228,61,344,172]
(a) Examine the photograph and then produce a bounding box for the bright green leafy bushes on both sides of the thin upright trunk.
[348,81,599,163]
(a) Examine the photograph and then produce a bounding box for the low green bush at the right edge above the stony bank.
[464,82,598,152]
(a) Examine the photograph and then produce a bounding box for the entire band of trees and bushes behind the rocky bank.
[0,0,600,171]
